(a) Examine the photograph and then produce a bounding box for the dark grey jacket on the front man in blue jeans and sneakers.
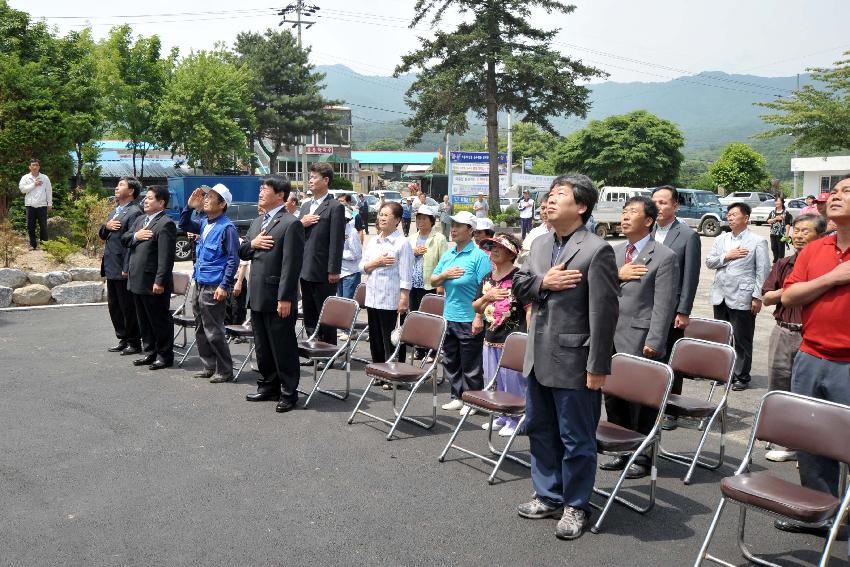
[513,227,620,390]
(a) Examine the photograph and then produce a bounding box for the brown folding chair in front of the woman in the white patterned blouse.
[348,311,446,441]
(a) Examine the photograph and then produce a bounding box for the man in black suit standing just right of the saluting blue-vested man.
[239,175,304,413]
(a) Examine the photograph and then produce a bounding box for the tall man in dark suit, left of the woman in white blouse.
[300,163,346,345]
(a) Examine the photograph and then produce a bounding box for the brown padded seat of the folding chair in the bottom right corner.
[720,472,841,524]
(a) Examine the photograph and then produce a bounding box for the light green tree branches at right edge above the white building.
[758,51,850,153]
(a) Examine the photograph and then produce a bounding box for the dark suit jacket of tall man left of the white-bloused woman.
[300,195,346,283]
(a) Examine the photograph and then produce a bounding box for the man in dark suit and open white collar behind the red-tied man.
[652,185,702,431]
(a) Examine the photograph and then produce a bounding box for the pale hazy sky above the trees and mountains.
[18,0,850,82]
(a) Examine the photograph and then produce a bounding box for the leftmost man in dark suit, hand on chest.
[98,177,142,355]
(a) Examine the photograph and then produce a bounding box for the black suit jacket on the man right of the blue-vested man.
[239,207,304,314]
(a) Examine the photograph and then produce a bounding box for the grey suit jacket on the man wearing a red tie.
[614,238,679,358]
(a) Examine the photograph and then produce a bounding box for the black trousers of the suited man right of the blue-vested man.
[251,306,301,402]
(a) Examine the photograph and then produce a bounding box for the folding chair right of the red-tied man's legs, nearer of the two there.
[659,338,735,484]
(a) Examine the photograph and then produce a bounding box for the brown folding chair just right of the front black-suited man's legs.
[298,296,360,408]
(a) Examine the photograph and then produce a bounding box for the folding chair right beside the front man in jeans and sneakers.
[590,354,673,533]
